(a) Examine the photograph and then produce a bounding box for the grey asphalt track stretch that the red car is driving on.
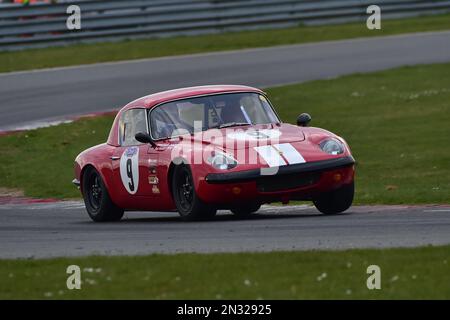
[0,202,450,258]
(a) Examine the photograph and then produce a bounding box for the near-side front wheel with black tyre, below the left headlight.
[172,165,217,221]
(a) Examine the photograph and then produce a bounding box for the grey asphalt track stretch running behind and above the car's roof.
[0,31,450,131]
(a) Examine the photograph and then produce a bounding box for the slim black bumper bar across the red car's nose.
[205,156,355,184]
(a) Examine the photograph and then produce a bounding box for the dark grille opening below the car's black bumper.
[256,172,320,192]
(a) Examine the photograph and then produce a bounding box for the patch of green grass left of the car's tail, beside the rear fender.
[0,116,113,198]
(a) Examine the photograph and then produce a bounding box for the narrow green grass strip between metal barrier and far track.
[0,14,450,72]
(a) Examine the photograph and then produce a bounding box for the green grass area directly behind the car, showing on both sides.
[0,64,450,204]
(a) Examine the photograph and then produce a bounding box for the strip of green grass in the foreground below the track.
[0,246,450,299]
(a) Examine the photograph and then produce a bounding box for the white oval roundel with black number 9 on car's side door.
[120,147,139,194]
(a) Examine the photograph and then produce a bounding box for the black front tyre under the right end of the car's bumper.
[313,182,355,214]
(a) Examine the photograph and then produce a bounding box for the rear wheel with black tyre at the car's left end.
[82,168,124,222]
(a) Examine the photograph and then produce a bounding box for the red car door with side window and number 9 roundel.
[111,108,157,209]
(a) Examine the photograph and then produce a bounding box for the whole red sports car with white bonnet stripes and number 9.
[73,85,355,221]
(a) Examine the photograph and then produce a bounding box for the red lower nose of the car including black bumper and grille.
[197,156,355,208]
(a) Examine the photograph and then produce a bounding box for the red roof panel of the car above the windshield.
[122,85,264,111]
